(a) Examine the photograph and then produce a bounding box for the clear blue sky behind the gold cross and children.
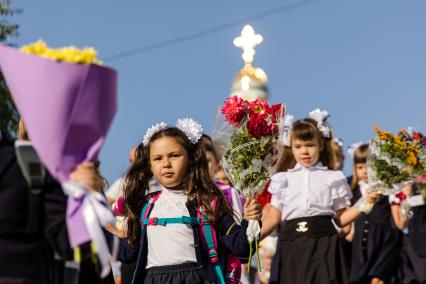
[13,0,426,182]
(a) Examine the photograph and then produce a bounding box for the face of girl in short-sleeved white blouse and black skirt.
[291,138,321,168]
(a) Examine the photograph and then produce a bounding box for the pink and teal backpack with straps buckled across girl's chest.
[141,191,241,284]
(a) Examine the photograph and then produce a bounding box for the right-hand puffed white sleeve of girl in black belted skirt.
[329,171,352,212]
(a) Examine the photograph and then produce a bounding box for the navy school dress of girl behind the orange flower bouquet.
[349,186,400,283]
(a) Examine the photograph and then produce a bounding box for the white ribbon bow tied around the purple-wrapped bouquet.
[62,181,119,278]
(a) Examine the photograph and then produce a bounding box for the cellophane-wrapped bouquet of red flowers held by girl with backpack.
[213,96,284,268]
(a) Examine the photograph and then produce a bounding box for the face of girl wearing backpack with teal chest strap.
[149,136,188,187]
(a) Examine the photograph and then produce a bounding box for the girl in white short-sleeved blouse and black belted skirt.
[261,113,379,284]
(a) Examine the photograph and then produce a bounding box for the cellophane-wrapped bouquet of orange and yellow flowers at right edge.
[367,126,426,195]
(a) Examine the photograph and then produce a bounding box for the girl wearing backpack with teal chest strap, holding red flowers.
[119,119,262,284]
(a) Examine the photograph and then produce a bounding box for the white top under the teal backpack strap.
[146,188,197,268]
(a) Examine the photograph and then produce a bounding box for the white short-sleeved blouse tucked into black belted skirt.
[268,162,352,221]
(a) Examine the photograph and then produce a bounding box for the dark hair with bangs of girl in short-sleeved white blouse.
[277,118,335,172]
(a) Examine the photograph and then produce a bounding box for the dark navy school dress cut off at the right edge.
[400,183,426,284]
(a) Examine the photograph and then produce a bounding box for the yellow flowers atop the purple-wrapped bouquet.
[21,39,102,65]
